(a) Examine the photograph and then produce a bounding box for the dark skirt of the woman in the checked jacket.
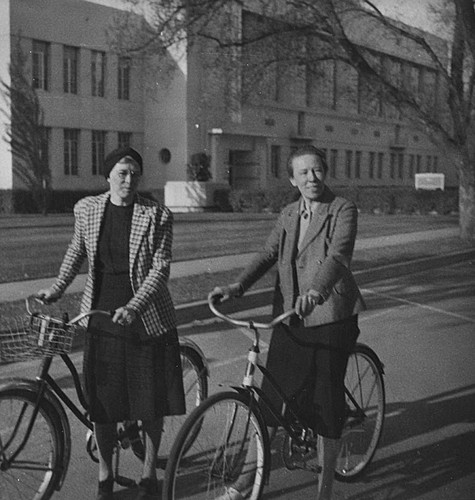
[83,275,185,423]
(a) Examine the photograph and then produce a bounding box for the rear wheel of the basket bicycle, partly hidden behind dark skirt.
[157,346,208,468]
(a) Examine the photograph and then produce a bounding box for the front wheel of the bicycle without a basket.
[163,392,269,500]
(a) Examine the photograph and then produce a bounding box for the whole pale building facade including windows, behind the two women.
[0,0,457,210]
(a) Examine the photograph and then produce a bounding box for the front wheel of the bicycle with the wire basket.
[0,387,64,500]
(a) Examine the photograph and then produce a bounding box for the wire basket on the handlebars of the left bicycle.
[0,313,77,362]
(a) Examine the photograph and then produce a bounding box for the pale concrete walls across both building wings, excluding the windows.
[0,0,457,205]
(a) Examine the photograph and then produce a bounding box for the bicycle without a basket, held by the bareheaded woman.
[163,298,385,500]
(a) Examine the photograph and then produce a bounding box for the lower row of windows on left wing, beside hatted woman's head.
[40,128,132,175]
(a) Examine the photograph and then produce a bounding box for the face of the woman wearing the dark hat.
[107,157,141,205]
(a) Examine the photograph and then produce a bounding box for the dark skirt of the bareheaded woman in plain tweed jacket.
[262,316,359,439]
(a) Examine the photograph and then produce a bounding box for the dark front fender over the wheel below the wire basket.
[0,377,71,491]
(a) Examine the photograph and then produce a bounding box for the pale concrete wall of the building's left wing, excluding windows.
[0,0,187,191]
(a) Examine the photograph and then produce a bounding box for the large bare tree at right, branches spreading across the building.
[111,0,475,240]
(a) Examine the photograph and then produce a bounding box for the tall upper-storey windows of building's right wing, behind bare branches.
[242,11,441,119]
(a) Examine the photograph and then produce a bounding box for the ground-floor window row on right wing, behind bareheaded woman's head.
[270,146,439,180]
